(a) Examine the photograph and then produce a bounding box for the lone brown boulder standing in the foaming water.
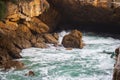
[62,30,83,48]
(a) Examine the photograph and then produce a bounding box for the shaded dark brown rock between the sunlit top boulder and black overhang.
[39,3,62,32]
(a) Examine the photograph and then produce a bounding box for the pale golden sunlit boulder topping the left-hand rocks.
[6,0,49,21]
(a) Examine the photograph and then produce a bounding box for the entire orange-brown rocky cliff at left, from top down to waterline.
[0,0,57,69]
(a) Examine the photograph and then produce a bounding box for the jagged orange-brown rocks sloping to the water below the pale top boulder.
[0,17,58,68]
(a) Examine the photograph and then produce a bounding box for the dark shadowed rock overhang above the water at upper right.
[48,0,120,32]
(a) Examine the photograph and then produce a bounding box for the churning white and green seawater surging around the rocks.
[0,31,120,80]
